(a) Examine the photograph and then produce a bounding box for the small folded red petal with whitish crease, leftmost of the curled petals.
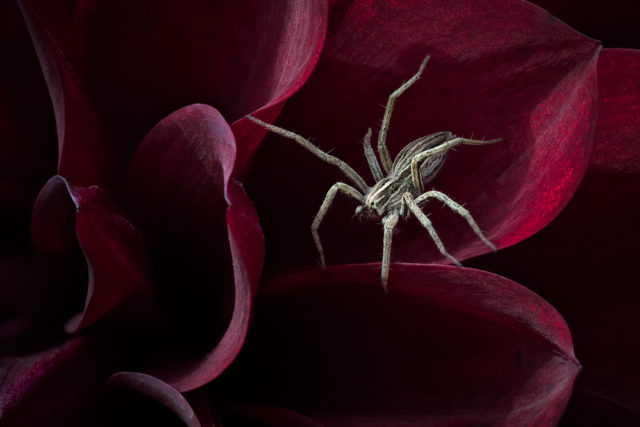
[32,176,149,332]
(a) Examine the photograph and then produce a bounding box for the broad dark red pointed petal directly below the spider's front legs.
[216,264,579,426]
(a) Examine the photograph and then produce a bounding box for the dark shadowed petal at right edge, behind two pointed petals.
[464,49,640,426]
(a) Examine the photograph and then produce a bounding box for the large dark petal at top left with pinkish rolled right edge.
[20,0,327,179]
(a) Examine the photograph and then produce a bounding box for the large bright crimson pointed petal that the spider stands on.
[247,0,599,274]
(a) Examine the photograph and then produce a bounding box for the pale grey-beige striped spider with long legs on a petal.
[248,55,502,290]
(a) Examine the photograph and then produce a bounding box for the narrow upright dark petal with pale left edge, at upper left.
[20,0,121,190]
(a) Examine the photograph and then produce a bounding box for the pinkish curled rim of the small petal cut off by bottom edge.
[109,372,201,427]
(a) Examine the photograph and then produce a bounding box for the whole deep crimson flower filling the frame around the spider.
[0,0,638,426]
